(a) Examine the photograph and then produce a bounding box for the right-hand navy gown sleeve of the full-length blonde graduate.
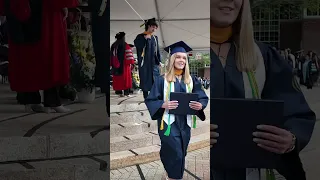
[192,76,209,121]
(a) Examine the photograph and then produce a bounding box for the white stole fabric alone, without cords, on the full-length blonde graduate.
[163,77,193,128]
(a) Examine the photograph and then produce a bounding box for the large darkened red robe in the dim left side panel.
[0,0,78,92]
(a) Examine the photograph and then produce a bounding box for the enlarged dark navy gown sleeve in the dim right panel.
[262,43,316,152]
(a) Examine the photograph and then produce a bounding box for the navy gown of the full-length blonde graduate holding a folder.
[145,76,208,179]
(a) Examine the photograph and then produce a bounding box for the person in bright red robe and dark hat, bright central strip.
[111,32,134,97]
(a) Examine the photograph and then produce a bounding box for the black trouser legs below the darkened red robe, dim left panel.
[17,88,61,107]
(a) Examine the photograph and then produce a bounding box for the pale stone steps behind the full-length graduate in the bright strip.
[110,91,210,169]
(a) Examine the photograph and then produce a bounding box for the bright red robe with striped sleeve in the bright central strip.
[112,43,134,91]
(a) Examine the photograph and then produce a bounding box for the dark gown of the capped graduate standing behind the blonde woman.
[134,34,161,91]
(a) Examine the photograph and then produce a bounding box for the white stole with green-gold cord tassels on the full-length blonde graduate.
[160,78,197,136]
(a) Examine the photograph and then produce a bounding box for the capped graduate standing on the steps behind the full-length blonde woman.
[134,18,161,98]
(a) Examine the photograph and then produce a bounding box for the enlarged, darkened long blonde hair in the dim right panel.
[233,0,261,72]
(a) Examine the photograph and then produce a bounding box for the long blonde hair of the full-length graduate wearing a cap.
[165,53,191,84]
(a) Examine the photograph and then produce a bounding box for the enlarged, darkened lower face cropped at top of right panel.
[210,0,242,28]
